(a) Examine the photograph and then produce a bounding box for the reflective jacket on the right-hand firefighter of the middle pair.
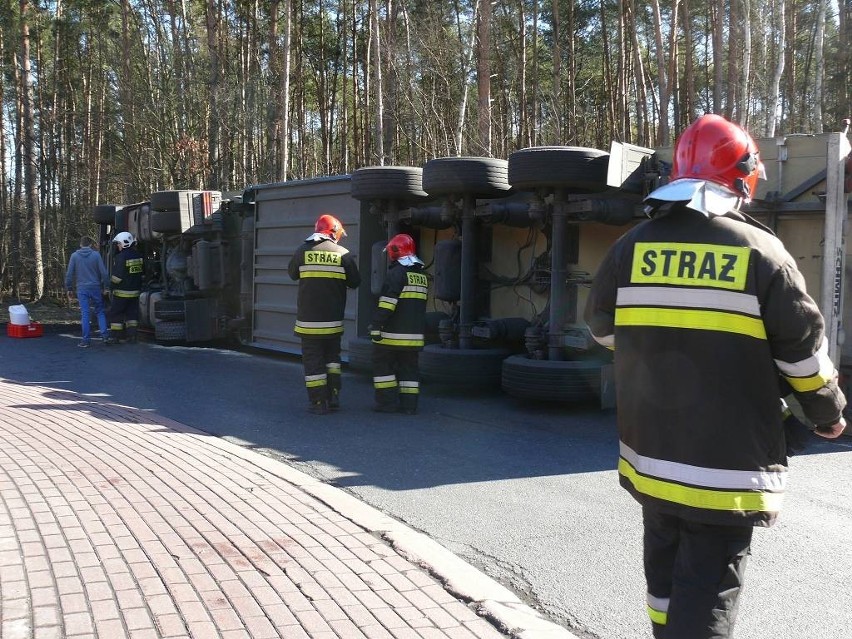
[370,262,429,348]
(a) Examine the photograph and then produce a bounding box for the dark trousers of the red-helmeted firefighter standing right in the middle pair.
[373,344,420,411]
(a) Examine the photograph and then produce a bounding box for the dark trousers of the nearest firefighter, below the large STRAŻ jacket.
[642,507,754,639]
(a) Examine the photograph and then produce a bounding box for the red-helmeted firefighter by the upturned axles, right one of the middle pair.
[370,233,429,415]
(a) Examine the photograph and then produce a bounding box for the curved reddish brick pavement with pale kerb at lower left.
[0,378,573,639]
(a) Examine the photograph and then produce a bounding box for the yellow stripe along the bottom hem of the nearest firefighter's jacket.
[618,457,784,512]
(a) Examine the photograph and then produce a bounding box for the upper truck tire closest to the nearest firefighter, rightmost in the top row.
[509,146,609,193]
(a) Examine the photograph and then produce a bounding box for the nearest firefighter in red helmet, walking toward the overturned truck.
[585,115,846,639]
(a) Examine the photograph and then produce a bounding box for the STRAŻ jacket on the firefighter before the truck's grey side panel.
[288,239,361,338]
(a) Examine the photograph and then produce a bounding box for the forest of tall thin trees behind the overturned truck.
[0,0,852,300]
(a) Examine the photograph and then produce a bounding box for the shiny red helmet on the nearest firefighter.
[671,113,763,202]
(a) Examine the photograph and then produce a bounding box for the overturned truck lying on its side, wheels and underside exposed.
[94,133,852,406]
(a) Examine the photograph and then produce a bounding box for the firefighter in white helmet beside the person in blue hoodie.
[107,231,143,344]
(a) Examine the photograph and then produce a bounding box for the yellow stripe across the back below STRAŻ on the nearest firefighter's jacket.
[615,308,766,339]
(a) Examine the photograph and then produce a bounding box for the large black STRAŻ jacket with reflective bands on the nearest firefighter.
[585,206,846,526]
